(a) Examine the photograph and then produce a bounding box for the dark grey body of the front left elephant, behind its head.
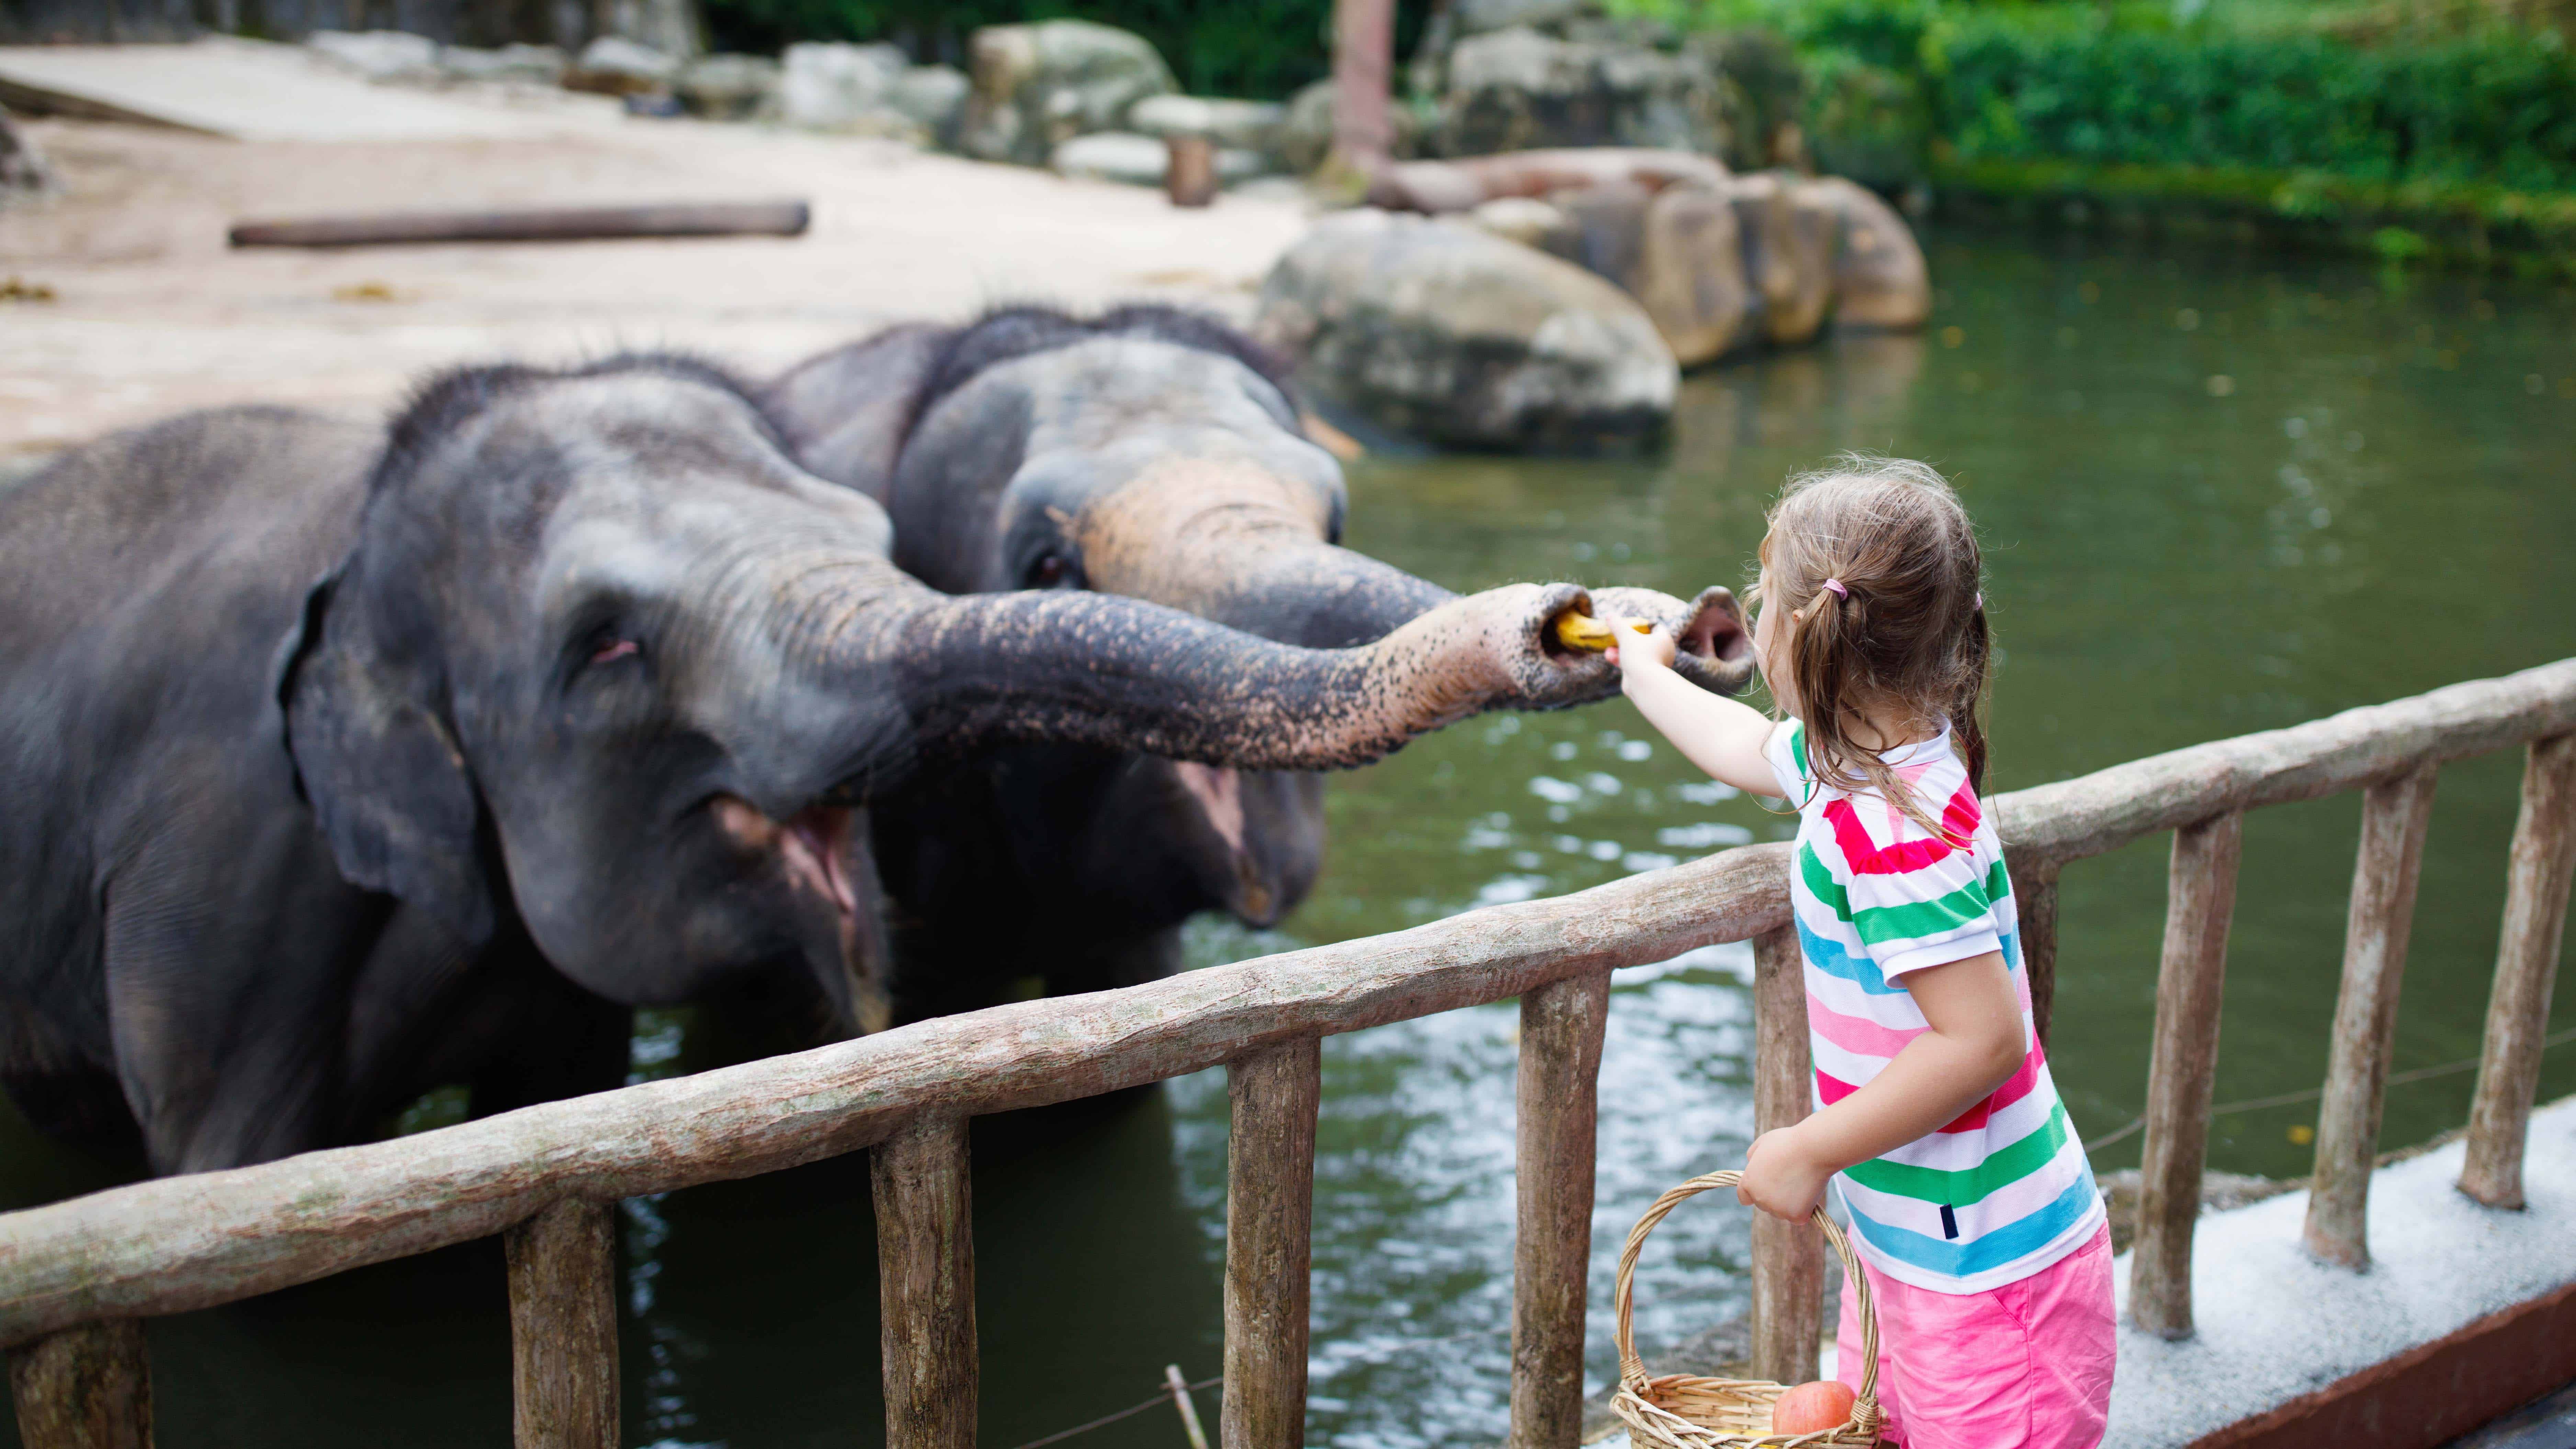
[0,410,605,1168]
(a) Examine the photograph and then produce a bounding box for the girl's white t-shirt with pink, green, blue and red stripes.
[1765,719,2105,1294]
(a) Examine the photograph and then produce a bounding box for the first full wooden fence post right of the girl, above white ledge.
[2128,812,2244,1338]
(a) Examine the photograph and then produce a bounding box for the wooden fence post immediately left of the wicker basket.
[1510,972,1610,1449]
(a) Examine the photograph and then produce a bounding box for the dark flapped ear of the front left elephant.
[278,572,492,946]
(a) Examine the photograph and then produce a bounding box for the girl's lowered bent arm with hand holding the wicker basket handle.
[1736,951,2030,1222]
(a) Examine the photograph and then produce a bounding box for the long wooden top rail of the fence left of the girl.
[0,846,1788,1346]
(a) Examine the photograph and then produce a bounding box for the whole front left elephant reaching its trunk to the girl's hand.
[0,353,1710,1173]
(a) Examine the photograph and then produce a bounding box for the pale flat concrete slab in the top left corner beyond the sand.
[0,36,616,142]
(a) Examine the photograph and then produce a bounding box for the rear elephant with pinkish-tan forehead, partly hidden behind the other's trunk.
[762,304,1752,1013]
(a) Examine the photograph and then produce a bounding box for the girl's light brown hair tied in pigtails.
[1762,454,1989,846]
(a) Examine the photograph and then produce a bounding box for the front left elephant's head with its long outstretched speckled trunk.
[278,356,1659,1029]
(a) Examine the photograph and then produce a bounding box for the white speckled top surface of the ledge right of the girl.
[2105,1101,2576,1449]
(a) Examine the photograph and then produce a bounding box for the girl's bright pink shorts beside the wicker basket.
[1834,1227,2115,1449]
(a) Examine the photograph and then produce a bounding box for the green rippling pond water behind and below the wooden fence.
[0,235,2576,1449]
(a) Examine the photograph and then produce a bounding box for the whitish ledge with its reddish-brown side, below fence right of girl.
[2105,1098,2576,1449]
